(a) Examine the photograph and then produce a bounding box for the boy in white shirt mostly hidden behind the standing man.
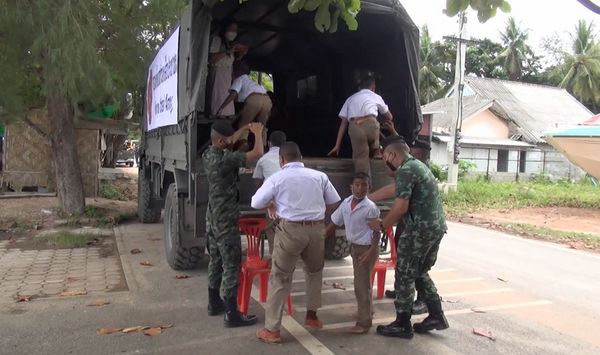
[252,131,287,255]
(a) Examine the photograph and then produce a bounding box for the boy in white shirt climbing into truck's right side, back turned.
[327,76,393,175]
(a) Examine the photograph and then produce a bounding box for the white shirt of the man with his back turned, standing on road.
[251,162,340,222]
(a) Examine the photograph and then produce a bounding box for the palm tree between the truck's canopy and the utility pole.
[419,26,442,104]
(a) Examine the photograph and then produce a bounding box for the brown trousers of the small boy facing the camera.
[350,244,378,328]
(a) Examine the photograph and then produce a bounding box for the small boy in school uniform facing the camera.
[327,172,380,334]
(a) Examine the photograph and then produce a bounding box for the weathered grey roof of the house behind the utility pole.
[423,76,592,143]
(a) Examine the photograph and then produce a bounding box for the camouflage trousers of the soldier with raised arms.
[206,220,242,299]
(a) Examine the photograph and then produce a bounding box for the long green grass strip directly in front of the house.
[442,181,600,213]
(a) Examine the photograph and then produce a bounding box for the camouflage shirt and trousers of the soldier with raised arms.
[202,146,246,299]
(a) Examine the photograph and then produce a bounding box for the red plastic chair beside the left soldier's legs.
[238,218,292,315]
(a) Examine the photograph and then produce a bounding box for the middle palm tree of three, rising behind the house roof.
[497,17,533,80]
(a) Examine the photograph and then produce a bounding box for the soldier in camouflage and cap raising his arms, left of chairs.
[202,121,263,327]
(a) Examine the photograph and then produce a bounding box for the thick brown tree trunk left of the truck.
[48,94,85,214]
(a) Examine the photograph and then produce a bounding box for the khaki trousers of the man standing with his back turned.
[265,221,325,331]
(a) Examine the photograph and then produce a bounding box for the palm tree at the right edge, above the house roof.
[560,20,600,108]
